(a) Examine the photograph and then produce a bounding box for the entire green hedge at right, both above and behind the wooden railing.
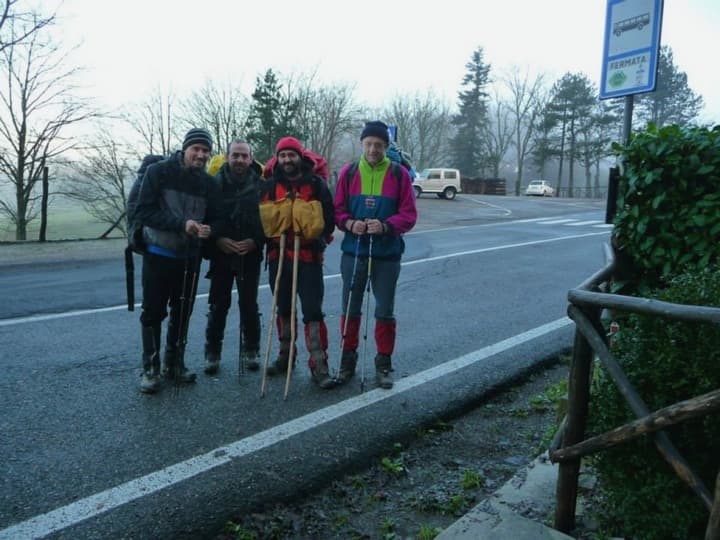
[588,125,720,540]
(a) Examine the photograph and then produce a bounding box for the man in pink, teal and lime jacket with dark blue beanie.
[335,121,417,388]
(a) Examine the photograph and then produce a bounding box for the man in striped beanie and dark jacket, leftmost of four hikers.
[135,128,220,394]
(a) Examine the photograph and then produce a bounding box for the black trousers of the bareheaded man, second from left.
[208,253,261,351]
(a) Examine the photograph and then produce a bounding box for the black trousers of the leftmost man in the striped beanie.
[140,253,201,348]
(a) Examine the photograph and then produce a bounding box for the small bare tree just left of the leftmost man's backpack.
[61,129,137,235]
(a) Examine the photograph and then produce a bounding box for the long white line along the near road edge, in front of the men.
[0,317,572,540]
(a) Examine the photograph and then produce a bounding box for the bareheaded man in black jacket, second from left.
[205,140,265,375]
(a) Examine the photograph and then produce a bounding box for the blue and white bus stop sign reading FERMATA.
[600,0,663,99]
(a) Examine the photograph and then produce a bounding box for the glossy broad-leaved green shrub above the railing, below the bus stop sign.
[613,124,720,291]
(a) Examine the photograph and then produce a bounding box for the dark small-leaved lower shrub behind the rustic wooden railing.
[588,269,720,540]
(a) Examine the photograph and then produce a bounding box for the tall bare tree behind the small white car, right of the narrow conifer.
[501,67,548,195]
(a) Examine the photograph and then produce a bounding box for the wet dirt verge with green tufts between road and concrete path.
[216,361,568,540]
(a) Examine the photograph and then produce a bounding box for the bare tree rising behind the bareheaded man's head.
[178,80,250,157]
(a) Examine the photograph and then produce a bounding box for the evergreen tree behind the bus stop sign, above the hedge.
[634,45,703,129]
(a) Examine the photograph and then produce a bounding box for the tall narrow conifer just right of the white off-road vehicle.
[450,47,490,176]
